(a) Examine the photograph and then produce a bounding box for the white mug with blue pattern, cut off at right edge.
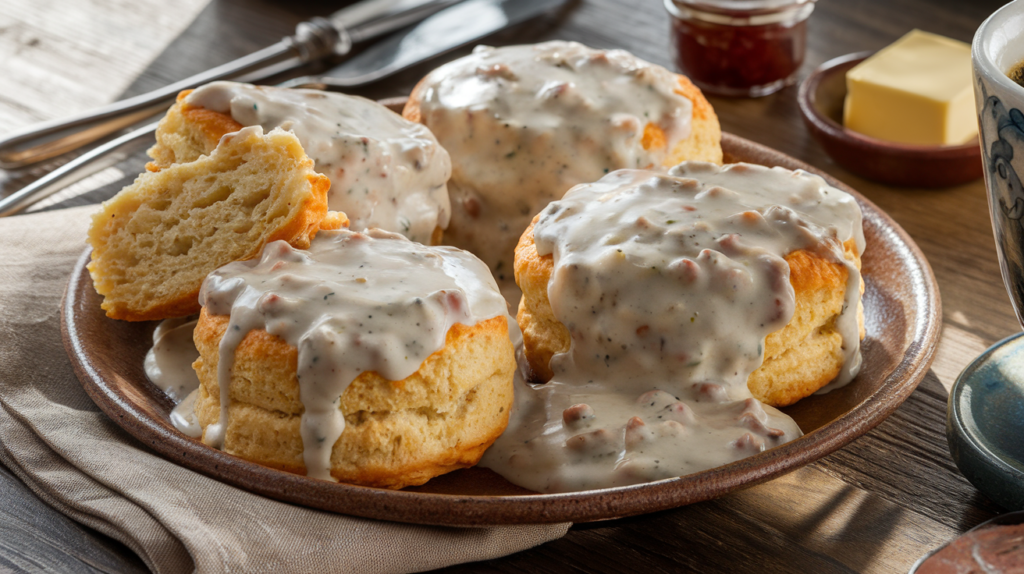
[971,0,1024,325]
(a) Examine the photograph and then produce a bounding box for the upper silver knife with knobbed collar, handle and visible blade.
[0,0,460,169]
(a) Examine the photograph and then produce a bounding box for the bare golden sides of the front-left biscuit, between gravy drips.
[194,310,515,489]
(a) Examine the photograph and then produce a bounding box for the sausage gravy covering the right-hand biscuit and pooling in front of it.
[481,163,864,492]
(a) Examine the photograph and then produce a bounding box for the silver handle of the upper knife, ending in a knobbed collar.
[0,17,352,169]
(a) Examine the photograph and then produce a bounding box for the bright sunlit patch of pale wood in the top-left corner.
[0,0,210,134]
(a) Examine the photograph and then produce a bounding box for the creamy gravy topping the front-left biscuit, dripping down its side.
[200,229,507,480]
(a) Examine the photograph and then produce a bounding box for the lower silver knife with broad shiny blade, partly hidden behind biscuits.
[0,0,568,217]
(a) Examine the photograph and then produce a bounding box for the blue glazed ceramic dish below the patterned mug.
[946,334,1024,511]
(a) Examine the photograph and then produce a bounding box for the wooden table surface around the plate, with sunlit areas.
[0,0,1007,572]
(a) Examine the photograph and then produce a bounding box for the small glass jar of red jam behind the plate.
[665,0,814,97]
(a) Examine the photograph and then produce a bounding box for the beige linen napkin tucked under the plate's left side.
[0,207,568,572]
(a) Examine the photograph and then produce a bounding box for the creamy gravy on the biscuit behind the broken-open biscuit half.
[185,82,452,244]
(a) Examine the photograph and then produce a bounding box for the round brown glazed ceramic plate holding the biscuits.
[61,127,942,526]
